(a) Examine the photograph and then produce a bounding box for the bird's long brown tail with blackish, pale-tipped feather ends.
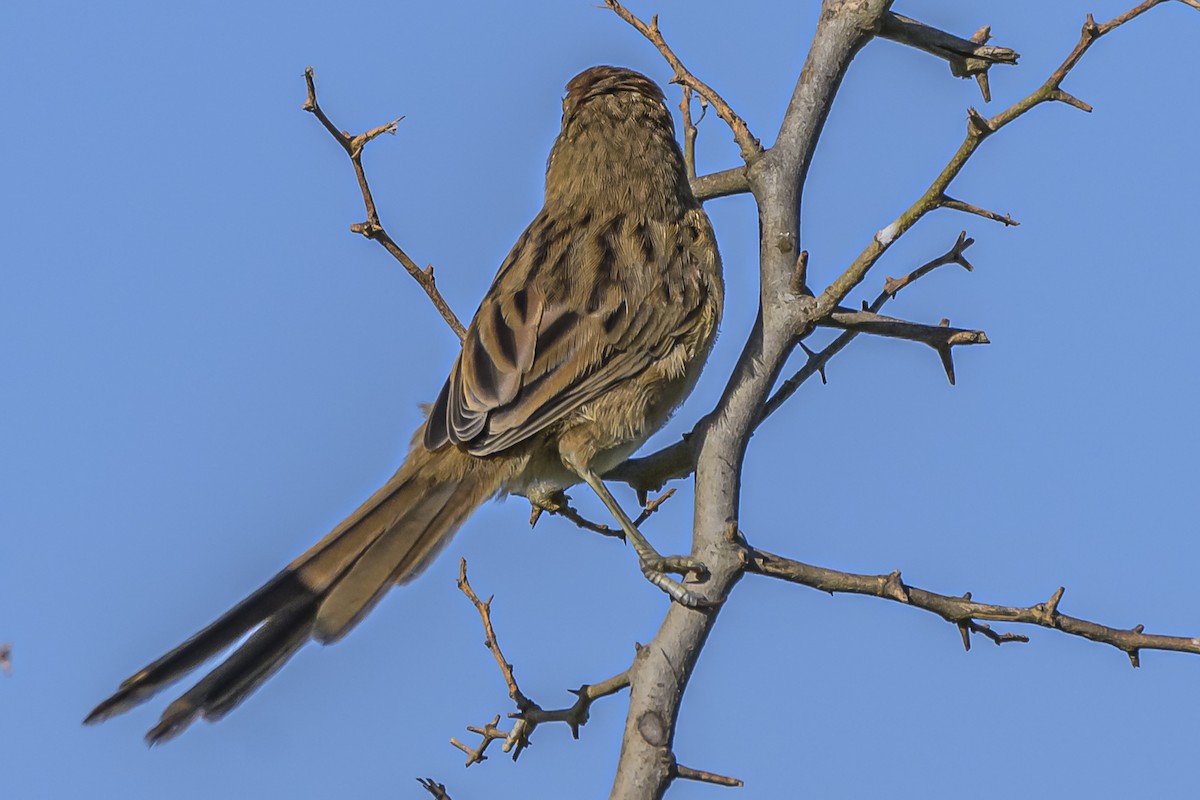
[84,445,504,745]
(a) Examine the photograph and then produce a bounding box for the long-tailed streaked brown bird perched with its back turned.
[85,66,724,744]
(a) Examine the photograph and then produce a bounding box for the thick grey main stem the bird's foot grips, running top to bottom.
[611,0,902,799]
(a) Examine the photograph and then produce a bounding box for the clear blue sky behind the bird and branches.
[0,0,1200,800]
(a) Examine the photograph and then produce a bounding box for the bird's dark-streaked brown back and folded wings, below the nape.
[425,211,710,456]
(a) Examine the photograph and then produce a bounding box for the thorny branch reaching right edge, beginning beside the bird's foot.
[745,547,1200,667]
